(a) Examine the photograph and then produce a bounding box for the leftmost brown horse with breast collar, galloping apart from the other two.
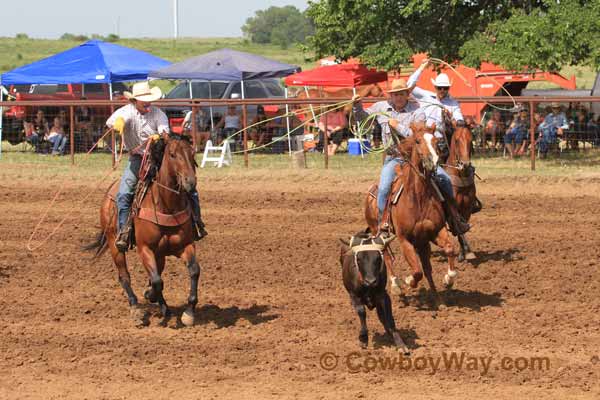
[87,135,200,326]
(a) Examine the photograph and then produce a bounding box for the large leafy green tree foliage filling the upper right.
[307,0,600,70]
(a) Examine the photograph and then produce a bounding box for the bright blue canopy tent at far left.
[0,40,170,156]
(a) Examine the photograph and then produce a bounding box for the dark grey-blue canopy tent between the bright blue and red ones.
[149,49,300,137]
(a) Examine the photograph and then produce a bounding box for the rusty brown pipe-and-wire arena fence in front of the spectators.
[0,96,600,170]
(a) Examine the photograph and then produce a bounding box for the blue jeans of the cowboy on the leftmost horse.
[117,154,200,230]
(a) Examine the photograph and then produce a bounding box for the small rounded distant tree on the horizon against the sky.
[242,6,314,48]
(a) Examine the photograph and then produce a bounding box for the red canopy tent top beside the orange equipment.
[285,64,387,87]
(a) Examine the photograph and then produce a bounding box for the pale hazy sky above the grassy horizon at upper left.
[0,0,308,39]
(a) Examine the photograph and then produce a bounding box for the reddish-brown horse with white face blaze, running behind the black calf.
[365,122,452,307]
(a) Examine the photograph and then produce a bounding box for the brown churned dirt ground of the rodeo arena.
[0,167,600,399]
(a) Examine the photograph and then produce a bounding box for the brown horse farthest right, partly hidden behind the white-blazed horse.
[444,126,477,261]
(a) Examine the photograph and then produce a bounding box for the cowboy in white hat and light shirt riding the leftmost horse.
[106,82,207,253]
